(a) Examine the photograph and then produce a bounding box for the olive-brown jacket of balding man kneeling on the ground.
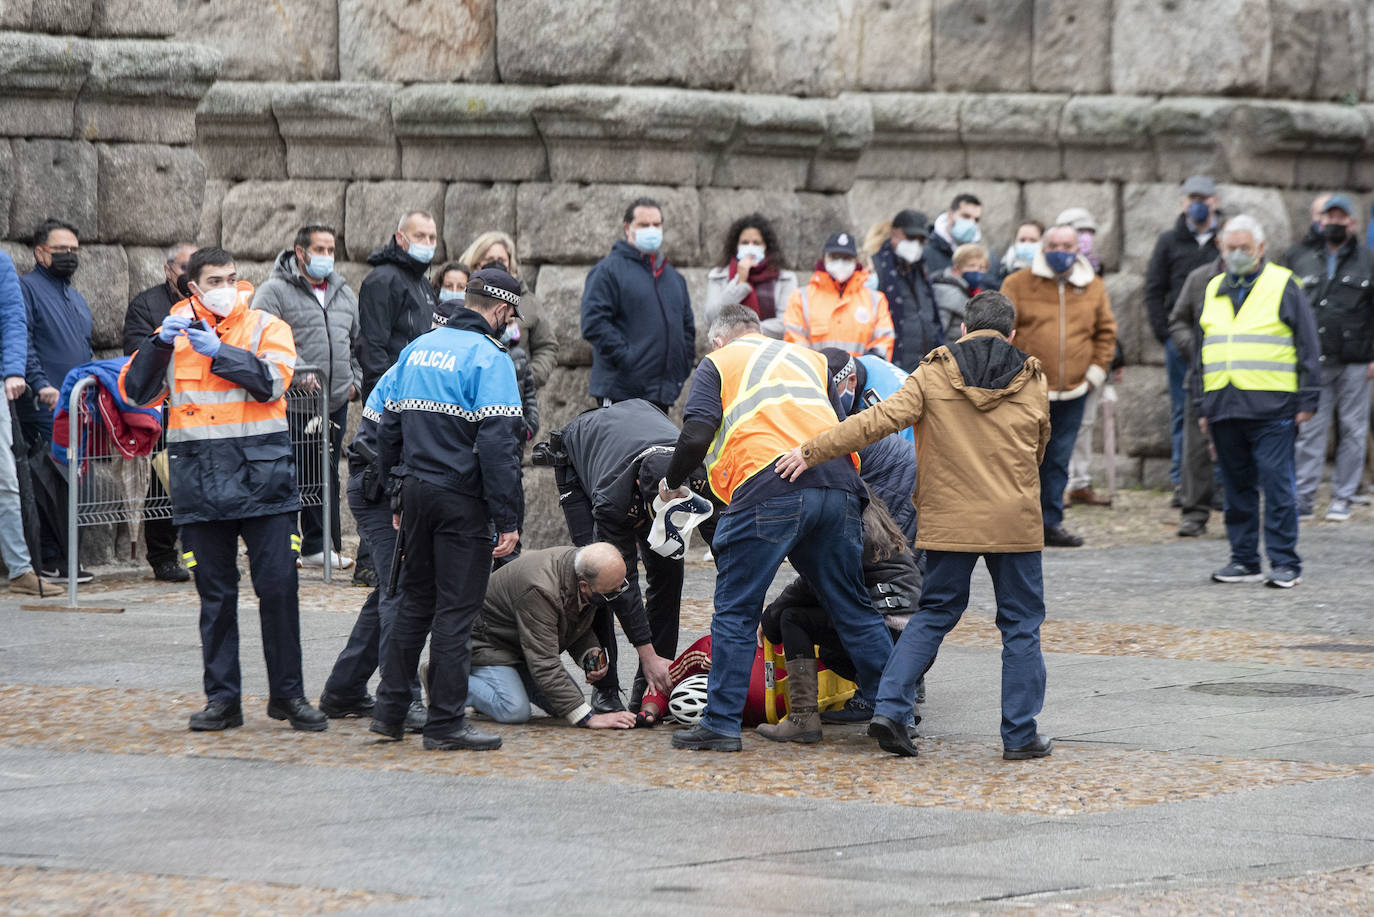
[473,547,599,725]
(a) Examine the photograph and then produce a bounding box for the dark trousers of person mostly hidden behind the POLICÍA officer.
[320,473,420,704]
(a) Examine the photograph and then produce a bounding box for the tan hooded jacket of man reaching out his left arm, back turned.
[801,331,1050,554]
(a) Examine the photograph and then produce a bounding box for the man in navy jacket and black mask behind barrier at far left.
[19,220,92,583]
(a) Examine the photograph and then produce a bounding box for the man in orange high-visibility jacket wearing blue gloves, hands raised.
[120,249,328,731]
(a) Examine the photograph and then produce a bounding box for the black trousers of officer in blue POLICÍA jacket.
[374,477,492,738]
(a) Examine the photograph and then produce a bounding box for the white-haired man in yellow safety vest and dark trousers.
[1193,214,1322,588]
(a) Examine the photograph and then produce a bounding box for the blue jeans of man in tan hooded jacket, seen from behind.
[875,551,1044,748]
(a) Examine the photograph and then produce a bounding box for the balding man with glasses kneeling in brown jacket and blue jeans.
[467,542,635,729]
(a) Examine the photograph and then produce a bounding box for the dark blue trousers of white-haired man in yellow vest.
[1208,418,1303,572]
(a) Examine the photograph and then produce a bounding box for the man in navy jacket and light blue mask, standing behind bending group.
[583,198,697,411]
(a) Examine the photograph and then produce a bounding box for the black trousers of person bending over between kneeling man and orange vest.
[554,465,684,692]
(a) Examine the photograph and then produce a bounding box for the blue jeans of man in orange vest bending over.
[701,486,895,736]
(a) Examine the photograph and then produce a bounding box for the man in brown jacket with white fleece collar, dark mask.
[1002,223,1116,547]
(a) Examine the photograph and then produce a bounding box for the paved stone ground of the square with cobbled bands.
[0,492,1374,914]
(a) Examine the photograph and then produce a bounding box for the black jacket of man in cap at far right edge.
[1285,235,1374,364]
